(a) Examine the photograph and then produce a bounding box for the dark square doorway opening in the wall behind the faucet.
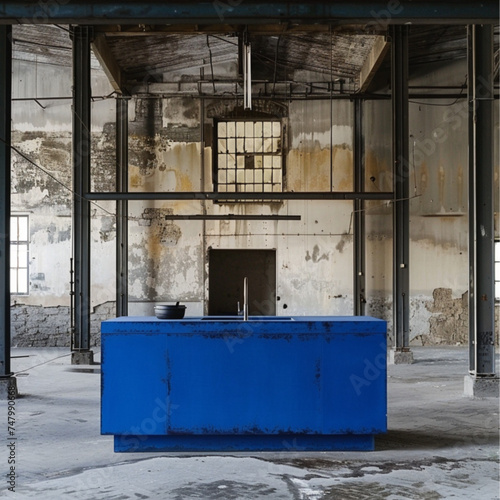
[208,250,276,316]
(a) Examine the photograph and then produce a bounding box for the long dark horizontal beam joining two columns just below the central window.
[85,191,394,201]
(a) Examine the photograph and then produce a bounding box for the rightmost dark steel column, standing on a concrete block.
[468,25,495,377]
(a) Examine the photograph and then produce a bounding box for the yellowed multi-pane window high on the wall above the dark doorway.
[215,120,283,193]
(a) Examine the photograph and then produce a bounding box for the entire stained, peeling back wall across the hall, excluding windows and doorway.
[8,51,498,345]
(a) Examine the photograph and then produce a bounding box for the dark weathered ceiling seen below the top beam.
[13,24,499,92]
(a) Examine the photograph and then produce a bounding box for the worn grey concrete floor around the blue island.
[0,347,500,500]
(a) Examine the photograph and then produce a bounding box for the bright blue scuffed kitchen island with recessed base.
[101,316,387,452]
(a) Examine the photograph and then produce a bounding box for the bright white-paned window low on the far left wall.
[10,215,29,295]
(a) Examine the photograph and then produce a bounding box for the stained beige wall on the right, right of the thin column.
[365,57,500,343]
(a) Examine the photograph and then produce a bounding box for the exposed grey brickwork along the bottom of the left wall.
[10,302,115,347]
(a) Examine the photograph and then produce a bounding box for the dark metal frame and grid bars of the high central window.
[212,116,286,197]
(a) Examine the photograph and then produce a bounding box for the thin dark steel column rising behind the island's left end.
[116,97,129,316]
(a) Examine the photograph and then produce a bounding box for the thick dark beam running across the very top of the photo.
[0,0,499,25]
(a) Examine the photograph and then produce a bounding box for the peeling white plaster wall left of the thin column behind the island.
[11,55,115,340]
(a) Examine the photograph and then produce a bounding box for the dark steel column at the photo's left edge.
[0,25,12,377]
